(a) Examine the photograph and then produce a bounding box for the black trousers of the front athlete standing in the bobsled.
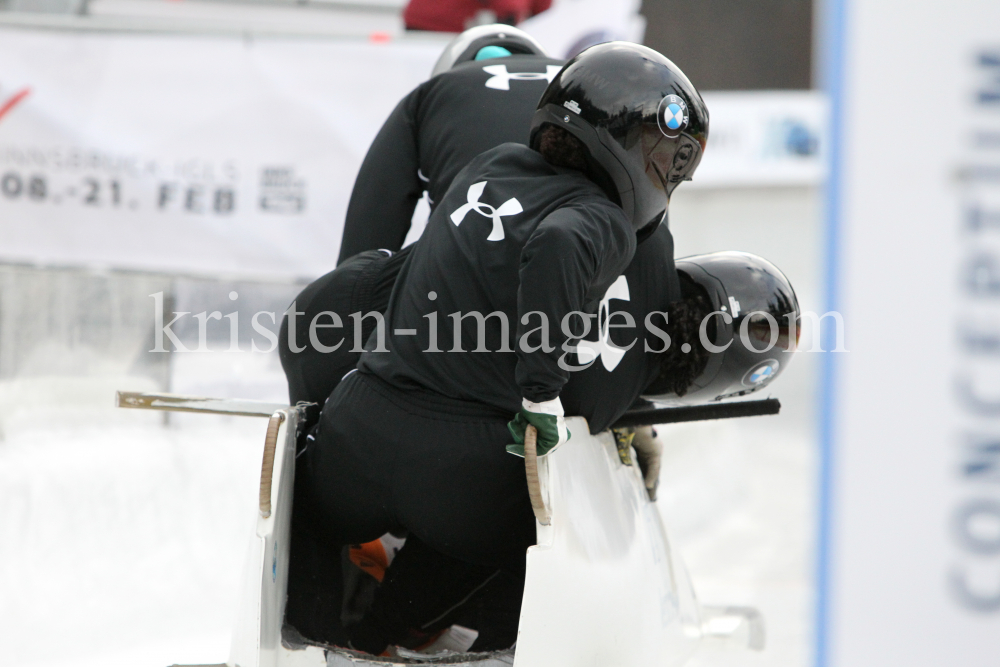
[289,372,535,652]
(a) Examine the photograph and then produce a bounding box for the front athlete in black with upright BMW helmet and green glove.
[290,43,707,653]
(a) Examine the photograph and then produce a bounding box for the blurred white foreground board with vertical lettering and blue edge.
[817,0,1000,667]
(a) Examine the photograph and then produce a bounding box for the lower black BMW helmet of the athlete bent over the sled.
[644,252,801,405]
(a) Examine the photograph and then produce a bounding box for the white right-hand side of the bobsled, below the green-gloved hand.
[514,417,701,667]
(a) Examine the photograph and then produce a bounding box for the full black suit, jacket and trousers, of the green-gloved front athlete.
[289,144,635,652]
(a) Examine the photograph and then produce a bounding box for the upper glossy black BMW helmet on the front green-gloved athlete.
[530,42,708,231]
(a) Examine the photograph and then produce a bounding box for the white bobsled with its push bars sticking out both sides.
[118,392,778,667]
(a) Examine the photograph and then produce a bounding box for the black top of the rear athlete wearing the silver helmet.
[339,55,563,262]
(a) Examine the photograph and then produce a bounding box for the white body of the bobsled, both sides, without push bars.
[222,409,701,667]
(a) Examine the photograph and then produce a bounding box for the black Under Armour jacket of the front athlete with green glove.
[358,144,636,413]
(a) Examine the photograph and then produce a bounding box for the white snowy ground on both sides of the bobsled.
[0,352,814,667]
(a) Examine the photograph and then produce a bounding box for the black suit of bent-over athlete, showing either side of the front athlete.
[278,217,680,433]
